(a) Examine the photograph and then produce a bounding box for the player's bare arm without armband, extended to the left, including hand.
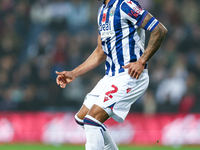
[56,35,106,88]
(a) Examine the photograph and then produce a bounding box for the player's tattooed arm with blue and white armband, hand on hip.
[123,13,168,79]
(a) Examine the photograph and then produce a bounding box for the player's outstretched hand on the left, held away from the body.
[55,71,75,88]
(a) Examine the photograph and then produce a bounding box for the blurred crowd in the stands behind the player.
[0,0,200,114]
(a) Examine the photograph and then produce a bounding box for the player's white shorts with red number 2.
[83,69,149,122]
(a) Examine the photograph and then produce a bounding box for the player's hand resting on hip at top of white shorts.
[122,61,145,79]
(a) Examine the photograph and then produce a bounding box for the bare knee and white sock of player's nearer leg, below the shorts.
[84,105,109,150]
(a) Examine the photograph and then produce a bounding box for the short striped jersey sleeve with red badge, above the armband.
[121,0,148,27]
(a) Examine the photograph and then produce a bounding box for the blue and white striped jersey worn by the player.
[98,0,148,76]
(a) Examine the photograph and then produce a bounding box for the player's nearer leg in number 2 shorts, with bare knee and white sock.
[84,70,148,150]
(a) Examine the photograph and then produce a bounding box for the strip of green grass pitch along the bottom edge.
[0,144,200,150]
